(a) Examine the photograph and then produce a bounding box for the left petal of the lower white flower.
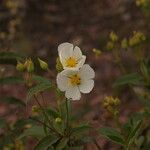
[56,72,69,91]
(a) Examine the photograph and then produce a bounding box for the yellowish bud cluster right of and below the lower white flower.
[103,96,120,115]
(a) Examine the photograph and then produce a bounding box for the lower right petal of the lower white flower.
[79,80,94,93]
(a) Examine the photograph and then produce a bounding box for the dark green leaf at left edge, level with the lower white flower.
[0,77,24,85]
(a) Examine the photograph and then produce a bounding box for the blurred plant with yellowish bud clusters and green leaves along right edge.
[93,31,150,150]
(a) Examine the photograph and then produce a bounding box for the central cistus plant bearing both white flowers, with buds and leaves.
[0,43,98,150]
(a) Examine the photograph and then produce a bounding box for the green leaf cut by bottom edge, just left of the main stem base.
[34,135,58,150]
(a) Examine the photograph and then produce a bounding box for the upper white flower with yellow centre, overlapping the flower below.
[58,43,86,70]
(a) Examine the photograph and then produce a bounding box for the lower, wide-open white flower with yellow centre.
[57,64,95,100]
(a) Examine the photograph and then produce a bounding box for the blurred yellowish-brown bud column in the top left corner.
[0,0,25,46]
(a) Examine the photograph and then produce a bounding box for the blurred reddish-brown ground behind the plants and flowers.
[0,0,150,150]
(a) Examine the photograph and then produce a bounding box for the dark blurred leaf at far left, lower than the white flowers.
[2,97,26,107]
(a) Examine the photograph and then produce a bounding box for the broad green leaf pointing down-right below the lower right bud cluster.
[99,127,124,145]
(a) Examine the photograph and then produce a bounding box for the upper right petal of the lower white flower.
[79,64,95,79]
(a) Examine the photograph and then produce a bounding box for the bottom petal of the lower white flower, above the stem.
[65,86,81,100]
